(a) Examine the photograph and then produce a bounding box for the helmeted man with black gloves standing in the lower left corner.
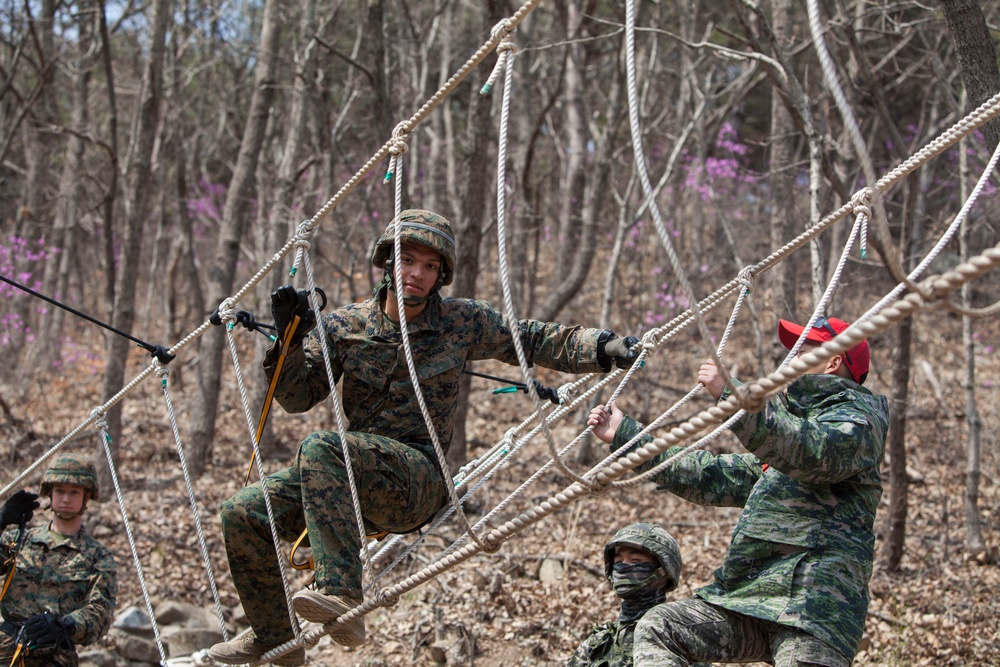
[0,454,118,667]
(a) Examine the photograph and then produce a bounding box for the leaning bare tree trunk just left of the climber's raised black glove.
[189,0,280,476]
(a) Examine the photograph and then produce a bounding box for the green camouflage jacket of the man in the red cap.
[612,375,889,659]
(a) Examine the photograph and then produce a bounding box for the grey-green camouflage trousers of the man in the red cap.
[633,598,851,667]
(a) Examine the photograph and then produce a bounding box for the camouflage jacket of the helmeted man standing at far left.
[0,526,118,646]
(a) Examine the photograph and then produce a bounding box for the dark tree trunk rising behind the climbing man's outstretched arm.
[448,0,504,469]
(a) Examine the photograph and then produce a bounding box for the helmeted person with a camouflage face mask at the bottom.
[566,523,682,667]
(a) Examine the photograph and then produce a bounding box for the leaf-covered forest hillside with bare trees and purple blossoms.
[0,0,1000,665]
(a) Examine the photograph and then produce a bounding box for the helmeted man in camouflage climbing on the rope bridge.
[209,210,638,665]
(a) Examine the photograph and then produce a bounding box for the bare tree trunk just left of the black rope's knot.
[97,0,172,485]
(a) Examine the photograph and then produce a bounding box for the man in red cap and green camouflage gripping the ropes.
[588,317,889,667]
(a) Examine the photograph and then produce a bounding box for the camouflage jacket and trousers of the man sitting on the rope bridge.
[222,294,601,645]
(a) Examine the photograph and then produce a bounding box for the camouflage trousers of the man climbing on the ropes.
[227,431,446,645]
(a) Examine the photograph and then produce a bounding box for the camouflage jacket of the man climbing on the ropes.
[264,294,603,449]
